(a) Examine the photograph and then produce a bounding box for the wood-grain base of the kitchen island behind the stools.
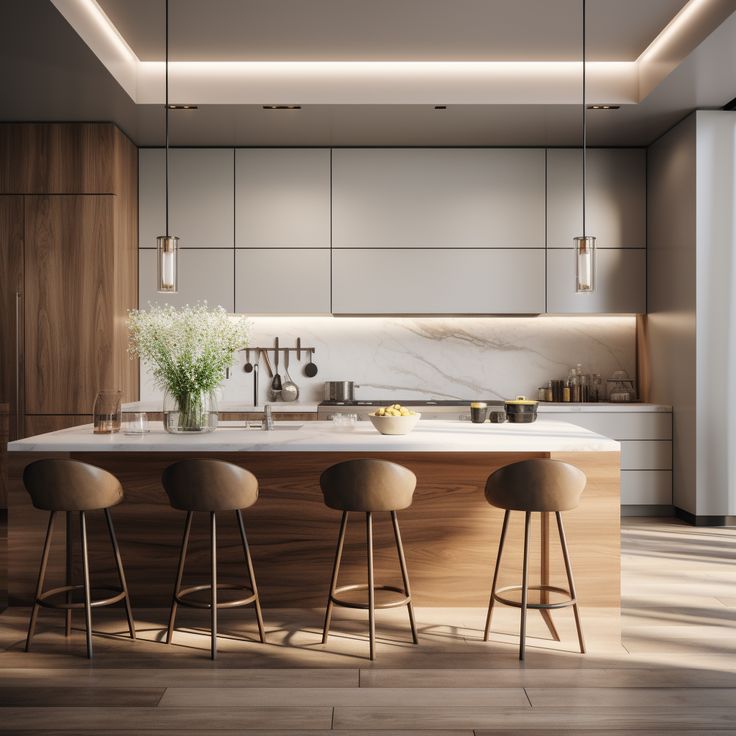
[8,452,620,610]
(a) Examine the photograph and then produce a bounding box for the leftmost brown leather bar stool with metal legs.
[23,458,135,659]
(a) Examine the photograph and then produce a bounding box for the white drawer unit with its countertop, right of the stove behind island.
[540,405,672,506]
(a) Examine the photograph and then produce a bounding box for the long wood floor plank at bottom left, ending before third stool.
[0,706,330,733]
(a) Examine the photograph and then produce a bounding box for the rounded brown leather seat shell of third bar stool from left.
[319,458,417,511]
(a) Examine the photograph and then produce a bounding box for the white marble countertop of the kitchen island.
[8,419,620,453]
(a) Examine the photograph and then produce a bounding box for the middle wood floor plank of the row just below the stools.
[159,687,530,708]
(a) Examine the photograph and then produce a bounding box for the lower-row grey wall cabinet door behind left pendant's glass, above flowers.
[138,248,235,312]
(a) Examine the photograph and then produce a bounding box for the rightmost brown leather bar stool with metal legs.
[483,458,587,659]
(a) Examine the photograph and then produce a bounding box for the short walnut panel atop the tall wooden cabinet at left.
[0,123,119,194]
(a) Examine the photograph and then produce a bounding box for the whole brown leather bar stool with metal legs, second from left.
[162,458,266,659]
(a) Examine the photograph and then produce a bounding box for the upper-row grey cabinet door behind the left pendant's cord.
[138,148,235,248]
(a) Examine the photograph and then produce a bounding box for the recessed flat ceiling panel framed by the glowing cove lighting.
[97,0,686,61]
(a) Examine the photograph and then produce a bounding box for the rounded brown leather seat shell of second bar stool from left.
[161,458,258,511]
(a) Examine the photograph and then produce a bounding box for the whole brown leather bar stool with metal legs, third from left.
[320,459,419,659]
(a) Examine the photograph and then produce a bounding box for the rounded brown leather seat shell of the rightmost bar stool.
[486,458,587,511]
